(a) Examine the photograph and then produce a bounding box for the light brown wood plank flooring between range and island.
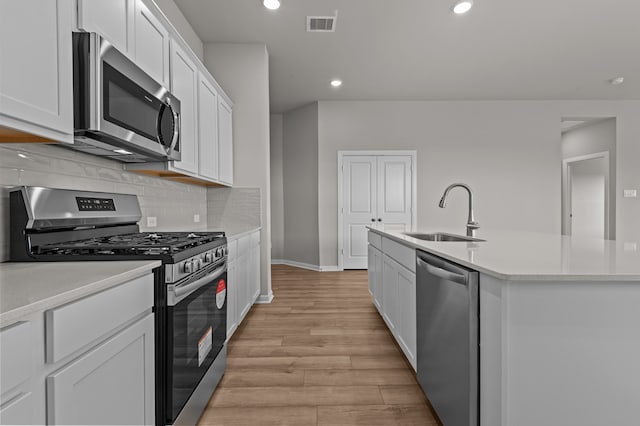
[199,265,439,426]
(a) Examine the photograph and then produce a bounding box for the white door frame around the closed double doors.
[338,150,418,271]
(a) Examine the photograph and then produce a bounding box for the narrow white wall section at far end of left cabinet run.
[204,43,272,300]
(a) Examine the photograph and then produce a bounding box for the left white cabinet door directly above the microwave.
[78,0,135,54]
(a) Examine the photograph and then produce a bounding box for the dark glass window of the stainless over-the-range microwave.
[102,62,163,141]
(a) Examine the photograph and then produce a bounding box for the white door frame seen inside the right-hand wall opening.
[562,151,611,240]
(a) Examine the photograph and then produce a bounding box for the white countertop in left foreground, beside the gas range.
[0,260,161,327]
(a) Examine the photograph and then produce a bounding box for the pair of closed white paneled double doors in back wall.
[339,155,413,269]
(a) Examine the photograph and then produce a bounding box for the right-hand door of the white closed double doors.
[376,155,412,232]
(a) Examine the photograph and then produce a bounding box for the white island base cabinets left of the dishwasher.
[368,231,417,370]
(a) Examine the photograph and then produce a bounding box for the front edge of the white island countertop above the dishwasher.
[367,226,640,282]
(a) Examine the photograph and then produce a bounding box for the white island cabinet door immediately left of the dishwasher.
[397,265,417,370]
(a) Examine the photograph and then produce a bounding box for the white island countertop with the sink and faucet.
[369,227,640,281]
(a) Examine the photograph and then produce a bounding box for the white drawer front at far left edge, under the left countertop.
[0,322,35,394]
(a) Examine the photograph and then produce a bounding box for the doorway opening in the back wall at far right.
[562,117,616,239]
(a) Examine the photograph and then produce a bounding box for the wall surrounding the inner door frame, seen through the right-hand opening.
[561,118,618,240]
